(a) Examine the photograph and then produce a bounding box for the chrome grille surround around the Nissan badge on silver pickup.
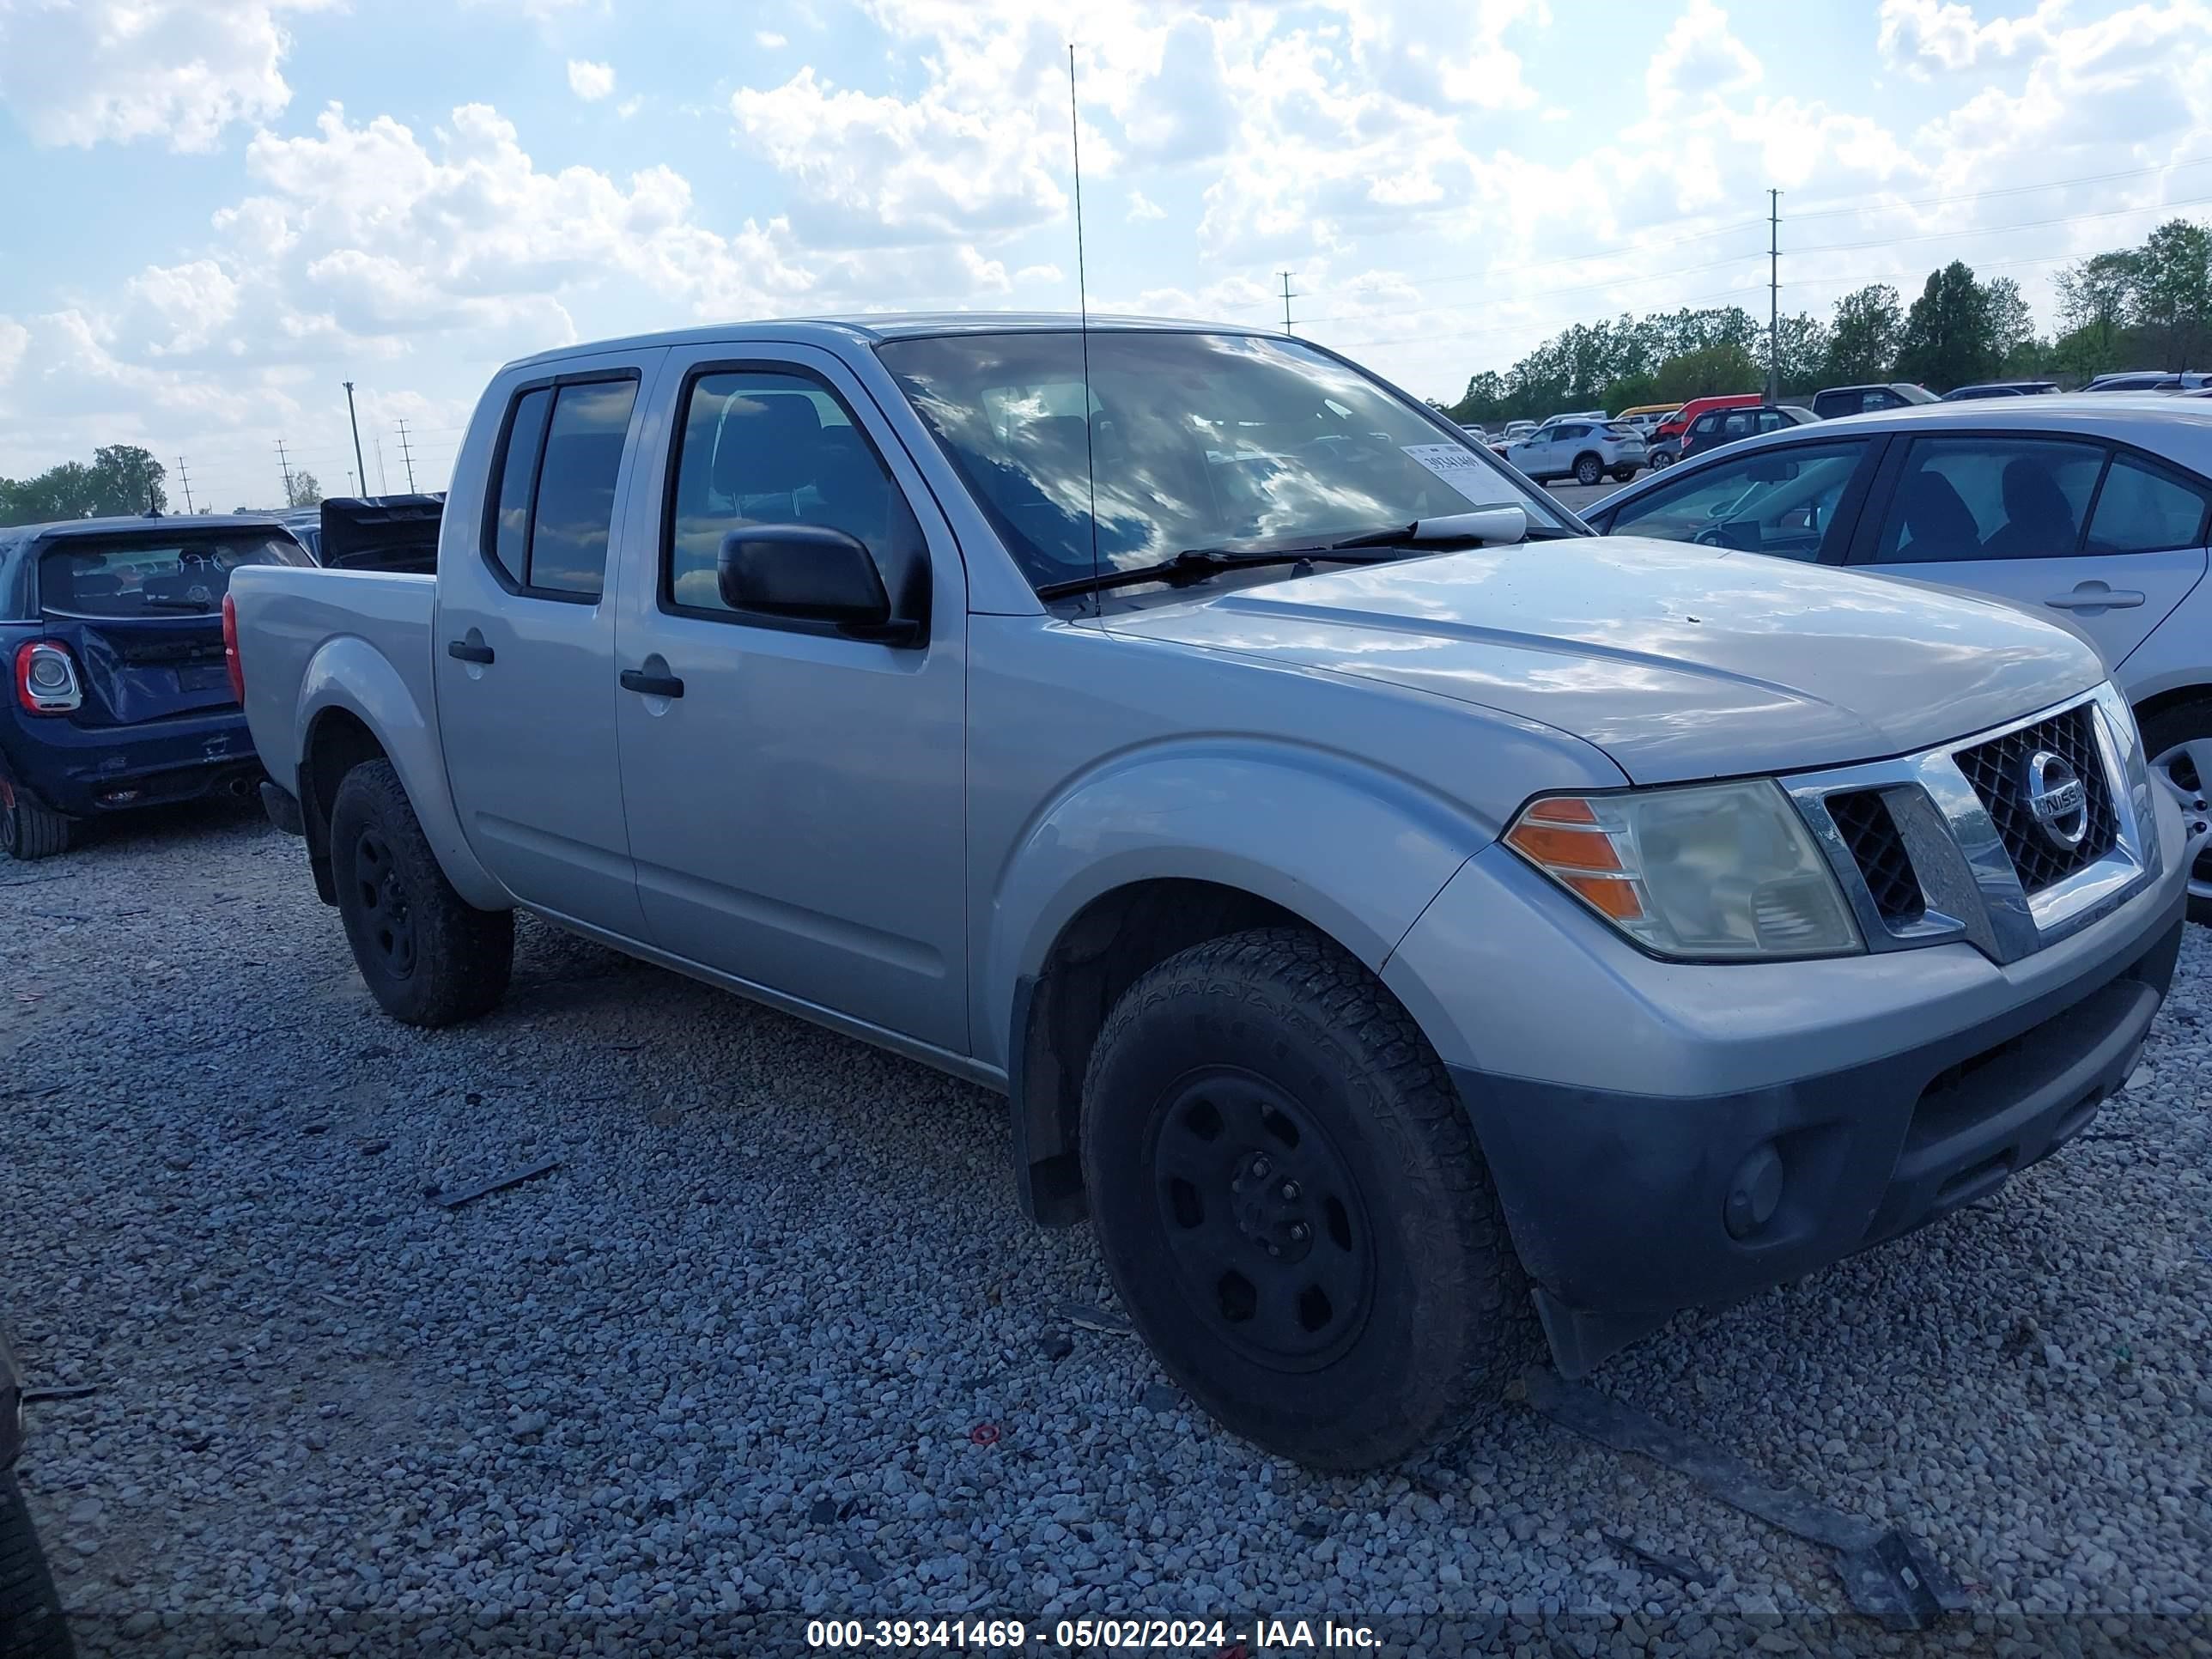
[1781,681,2163,963]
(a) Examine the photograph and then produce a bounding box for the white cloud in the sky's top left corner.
[0,0,327,150]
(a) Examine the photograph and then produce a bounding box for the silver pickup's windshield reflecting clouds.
[878,330,1573,588]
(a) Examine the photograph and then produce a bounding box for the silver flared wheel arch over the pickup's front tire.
[975,741,1495,1066]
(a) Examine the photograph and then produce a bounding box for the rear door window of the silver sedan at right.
[1874,438,2104,564]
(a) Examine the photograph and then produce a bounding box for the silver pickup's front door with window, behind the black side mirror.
[615,347,967,1053]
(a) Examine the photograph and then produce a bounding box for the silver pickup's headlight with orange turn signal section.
[1506,779,1865,957]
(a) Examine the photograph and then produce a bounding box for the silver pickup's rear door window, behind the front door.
[484,372,637,604]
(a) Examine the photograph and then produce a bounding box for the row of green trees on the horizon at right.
[1449,219,2212,425]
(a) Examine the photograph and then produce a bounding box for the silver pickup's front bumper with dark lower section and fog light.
[1385,792,2185,1376]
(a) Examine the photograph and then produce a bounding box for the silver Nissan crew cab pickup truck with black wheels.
[226,314,2201,1467]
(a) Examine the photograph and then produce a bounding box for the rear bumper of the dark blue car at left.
[7,708,261,818]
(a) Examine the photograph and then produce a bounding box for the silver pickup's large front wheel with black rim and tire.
[1082,929,1533,1468]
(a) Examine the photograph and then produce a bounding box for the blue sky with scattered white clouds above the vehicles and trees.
[0,0,2212,507]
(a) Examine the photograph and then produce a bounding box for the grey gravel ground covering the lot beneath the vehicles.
[0,810,2212,1655]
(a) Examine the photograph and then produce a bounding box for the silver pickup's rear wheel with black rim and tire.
[330,761,515,1026]
